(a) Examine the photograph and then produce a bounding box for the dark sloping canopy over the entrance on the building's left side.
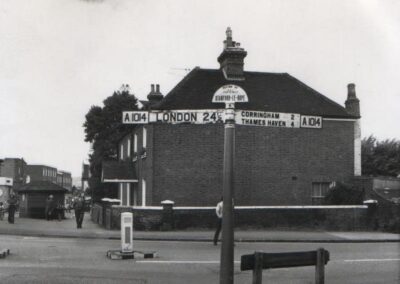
[101,161,138,183]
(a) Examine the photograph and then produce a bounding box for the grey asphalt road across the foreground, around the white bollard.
[0,235,400,284]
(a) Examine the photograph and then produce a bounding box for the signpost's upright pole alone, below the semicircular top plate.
[220,103,235,284]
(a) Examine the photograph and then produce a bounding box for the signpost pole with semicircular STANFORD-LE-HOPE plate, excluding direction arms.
[212,85,248,284]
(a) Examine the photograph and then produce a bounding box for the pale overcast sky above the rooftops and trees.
[0,0,400,177]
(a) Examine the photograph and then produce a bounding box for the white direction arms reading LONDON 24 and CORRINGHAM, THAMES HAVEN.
[122,109,322,128]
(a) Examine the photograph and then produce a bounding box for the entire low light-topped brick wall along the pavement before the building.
[92,205,371,231]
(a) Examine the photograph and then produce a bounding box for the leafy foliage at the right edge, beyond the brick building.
[361,135,400,177]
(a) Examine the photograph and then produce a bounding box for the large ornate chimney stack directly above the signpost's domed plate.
[218,27,247,80]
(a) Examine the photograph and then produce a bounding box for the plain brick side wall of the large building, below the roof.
[146,120,354,206]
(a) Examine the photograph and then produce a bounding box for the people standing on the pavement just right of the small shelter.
[45,194,85,229]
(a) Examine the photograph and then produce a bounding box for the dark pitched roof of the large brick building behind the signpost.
[153,67,356,118]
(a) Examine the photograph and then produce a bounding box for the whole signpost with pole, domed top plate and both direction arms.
[122,84,322,284]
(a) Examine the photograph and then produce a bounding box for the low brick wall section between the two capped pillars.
[174,206,368,231]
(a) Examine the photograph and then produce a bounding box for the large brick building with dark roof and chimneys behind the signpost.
[103,29,361,206]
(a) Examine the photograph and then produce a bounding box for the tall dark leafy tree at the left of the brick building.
[83,85,138,201]
